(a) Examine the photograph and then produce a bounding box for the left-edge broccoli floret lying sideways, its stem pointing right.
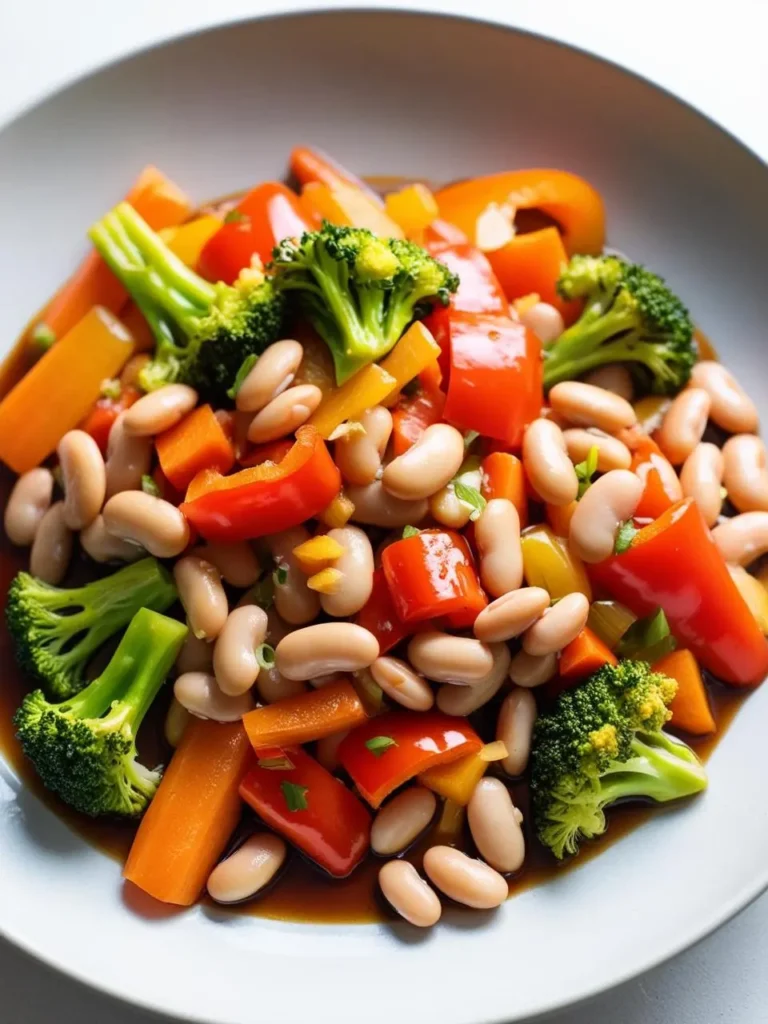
[6,558,176,700]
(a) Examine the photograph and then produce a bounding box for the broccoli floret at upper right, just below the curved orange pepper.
[544,256,696,394]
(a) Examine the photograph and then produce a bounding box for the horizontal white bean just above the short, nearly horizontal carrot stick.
[275,623,379,680]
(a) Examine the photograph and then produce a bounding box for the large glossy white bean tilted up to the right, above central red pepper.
[382,423,465,502]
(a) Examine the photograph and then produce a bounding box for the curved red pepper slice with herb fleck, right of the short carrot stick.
[338,711,482,808]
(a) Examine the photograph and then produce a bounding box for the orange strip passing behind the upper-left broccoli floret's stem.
[31,167,191,340]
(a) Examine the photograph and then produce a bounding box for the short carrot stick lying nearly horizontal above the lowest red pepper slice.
[243,679,368,751]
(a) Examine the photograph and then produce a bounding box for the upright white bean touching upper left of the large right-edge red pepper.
[569,469,644,565]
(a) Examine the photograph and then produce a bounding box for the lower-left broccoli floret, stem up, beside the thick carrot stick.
[13,608,186,818]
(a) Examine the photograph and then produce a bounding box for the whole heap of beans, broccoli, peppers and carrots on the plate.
[0,147,768,928]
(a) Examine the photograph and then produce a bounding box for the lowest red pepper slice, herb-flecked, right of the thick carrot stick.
[240,746,371,879]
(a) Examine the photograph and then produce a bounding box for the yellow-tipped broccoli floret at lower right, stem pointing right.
[530,662,707,858]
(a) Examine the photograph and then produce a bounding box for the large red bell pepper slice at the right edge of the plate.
[591,499,768,686]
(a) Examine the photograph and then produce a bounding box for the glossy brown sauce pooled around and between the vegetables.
[0,177,740,924]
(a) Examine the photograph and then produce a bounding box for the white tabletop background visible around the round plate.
[0,0,768,1024]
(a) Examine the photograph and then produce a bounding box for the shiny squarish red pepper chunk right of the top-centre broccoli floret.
[443,313,544,447]
